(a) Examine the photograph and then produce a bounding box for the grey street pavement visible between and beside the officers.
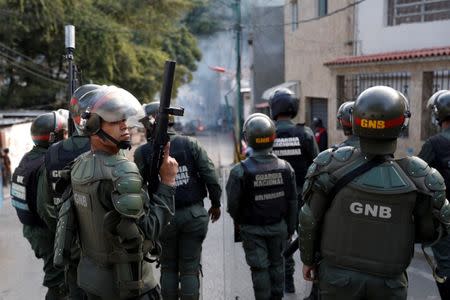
[0,133,439,300]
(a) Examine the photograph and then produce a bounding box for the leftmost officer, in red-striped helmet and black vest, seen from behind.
[11,112,67,300]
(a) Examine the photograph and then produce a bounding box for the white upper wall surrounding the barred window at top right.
[356,0,450,55]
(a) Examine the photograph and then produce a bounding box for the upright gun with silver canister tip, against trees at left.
[64,25,78,136]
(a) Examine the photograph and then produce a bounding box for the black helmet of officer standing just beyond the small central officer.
[269,88,299,120]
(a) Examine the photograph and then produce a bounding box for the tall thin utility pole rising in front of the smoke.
[235,0,244,157]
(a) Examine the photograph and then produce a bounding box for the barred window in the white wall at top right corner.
[387,0,450,26]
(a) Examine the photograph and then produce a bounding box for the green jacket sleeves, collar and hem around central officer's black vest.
[226,151,297,235]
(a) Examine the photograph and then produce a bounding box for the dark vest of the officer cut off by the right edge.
[430,134,450,199]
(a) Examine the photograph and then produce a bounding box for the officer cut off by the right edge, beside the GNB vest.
[418,90,450,299]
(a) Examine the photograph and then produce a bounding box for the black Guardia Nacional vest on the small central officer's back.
[238,157,293,226]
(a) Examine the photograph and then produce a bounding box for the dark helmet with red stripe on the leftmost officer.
[30,111,67,148]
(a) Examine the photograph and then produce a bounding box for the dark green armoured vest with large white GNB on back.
[320,161,417,277]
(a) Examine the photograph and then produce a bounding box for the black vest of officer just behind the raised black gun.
[141,135,207,209]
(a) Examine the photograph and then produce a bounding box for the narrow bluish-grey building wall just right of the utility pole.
[251,6,284,104]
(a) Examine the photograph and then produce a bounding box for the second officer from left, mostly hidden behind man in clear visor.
[38,84,101,300]
